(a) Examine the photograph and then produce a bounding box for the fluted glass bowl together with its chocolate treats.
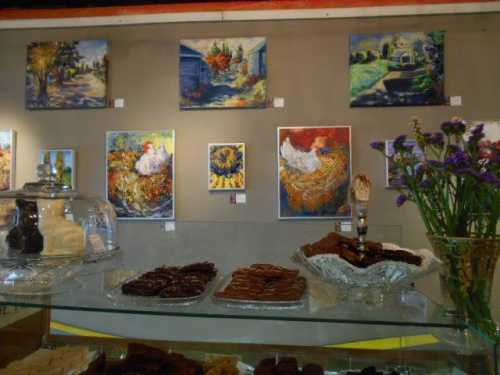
[292,232,441,290]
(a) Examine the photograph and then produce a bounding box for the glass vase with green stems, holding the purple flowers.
[427,235,500,340]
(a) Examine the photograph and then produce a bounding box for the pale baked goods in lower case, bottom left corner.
[0,346,90,375]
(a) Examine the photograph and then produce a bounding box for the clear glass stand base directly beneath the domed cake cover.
[0,257,83,295]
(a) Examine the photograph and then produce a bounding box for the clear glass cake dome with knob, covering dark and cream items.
[0,161,118,261]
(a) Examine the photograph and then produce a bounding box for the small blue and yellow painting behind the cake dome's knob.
[39,149,76,190]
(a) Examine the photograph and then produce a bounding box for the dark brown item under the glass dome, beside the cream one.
[6,199,43,254]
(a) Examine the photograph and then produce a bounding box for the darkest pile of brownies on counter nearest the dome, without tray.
[121,262,217,298]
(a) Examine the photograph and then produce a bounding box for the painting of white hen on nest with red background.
[278,126,351,219]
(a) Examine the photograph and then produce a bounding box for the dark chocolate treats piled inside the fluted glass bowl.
[302,232,422,268]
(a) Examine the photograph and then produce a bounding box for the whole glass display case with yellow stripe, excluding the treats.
[0,222,500,375]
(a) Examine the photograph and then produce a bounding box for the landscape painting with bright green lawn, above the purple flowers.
[349,31,446,107]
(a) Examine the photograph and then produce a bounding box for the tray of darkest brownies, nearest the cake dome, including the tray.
[107,262,217,306]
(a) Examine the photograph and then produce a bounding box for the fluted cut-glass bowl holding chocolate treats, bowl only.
[292,243,441,302]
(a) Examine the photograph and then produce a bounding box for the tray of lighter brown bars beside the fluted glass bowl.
[214,264,307,309]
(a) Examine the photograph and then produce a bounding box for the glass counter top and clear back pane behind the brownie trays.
[0,222,490,328]
